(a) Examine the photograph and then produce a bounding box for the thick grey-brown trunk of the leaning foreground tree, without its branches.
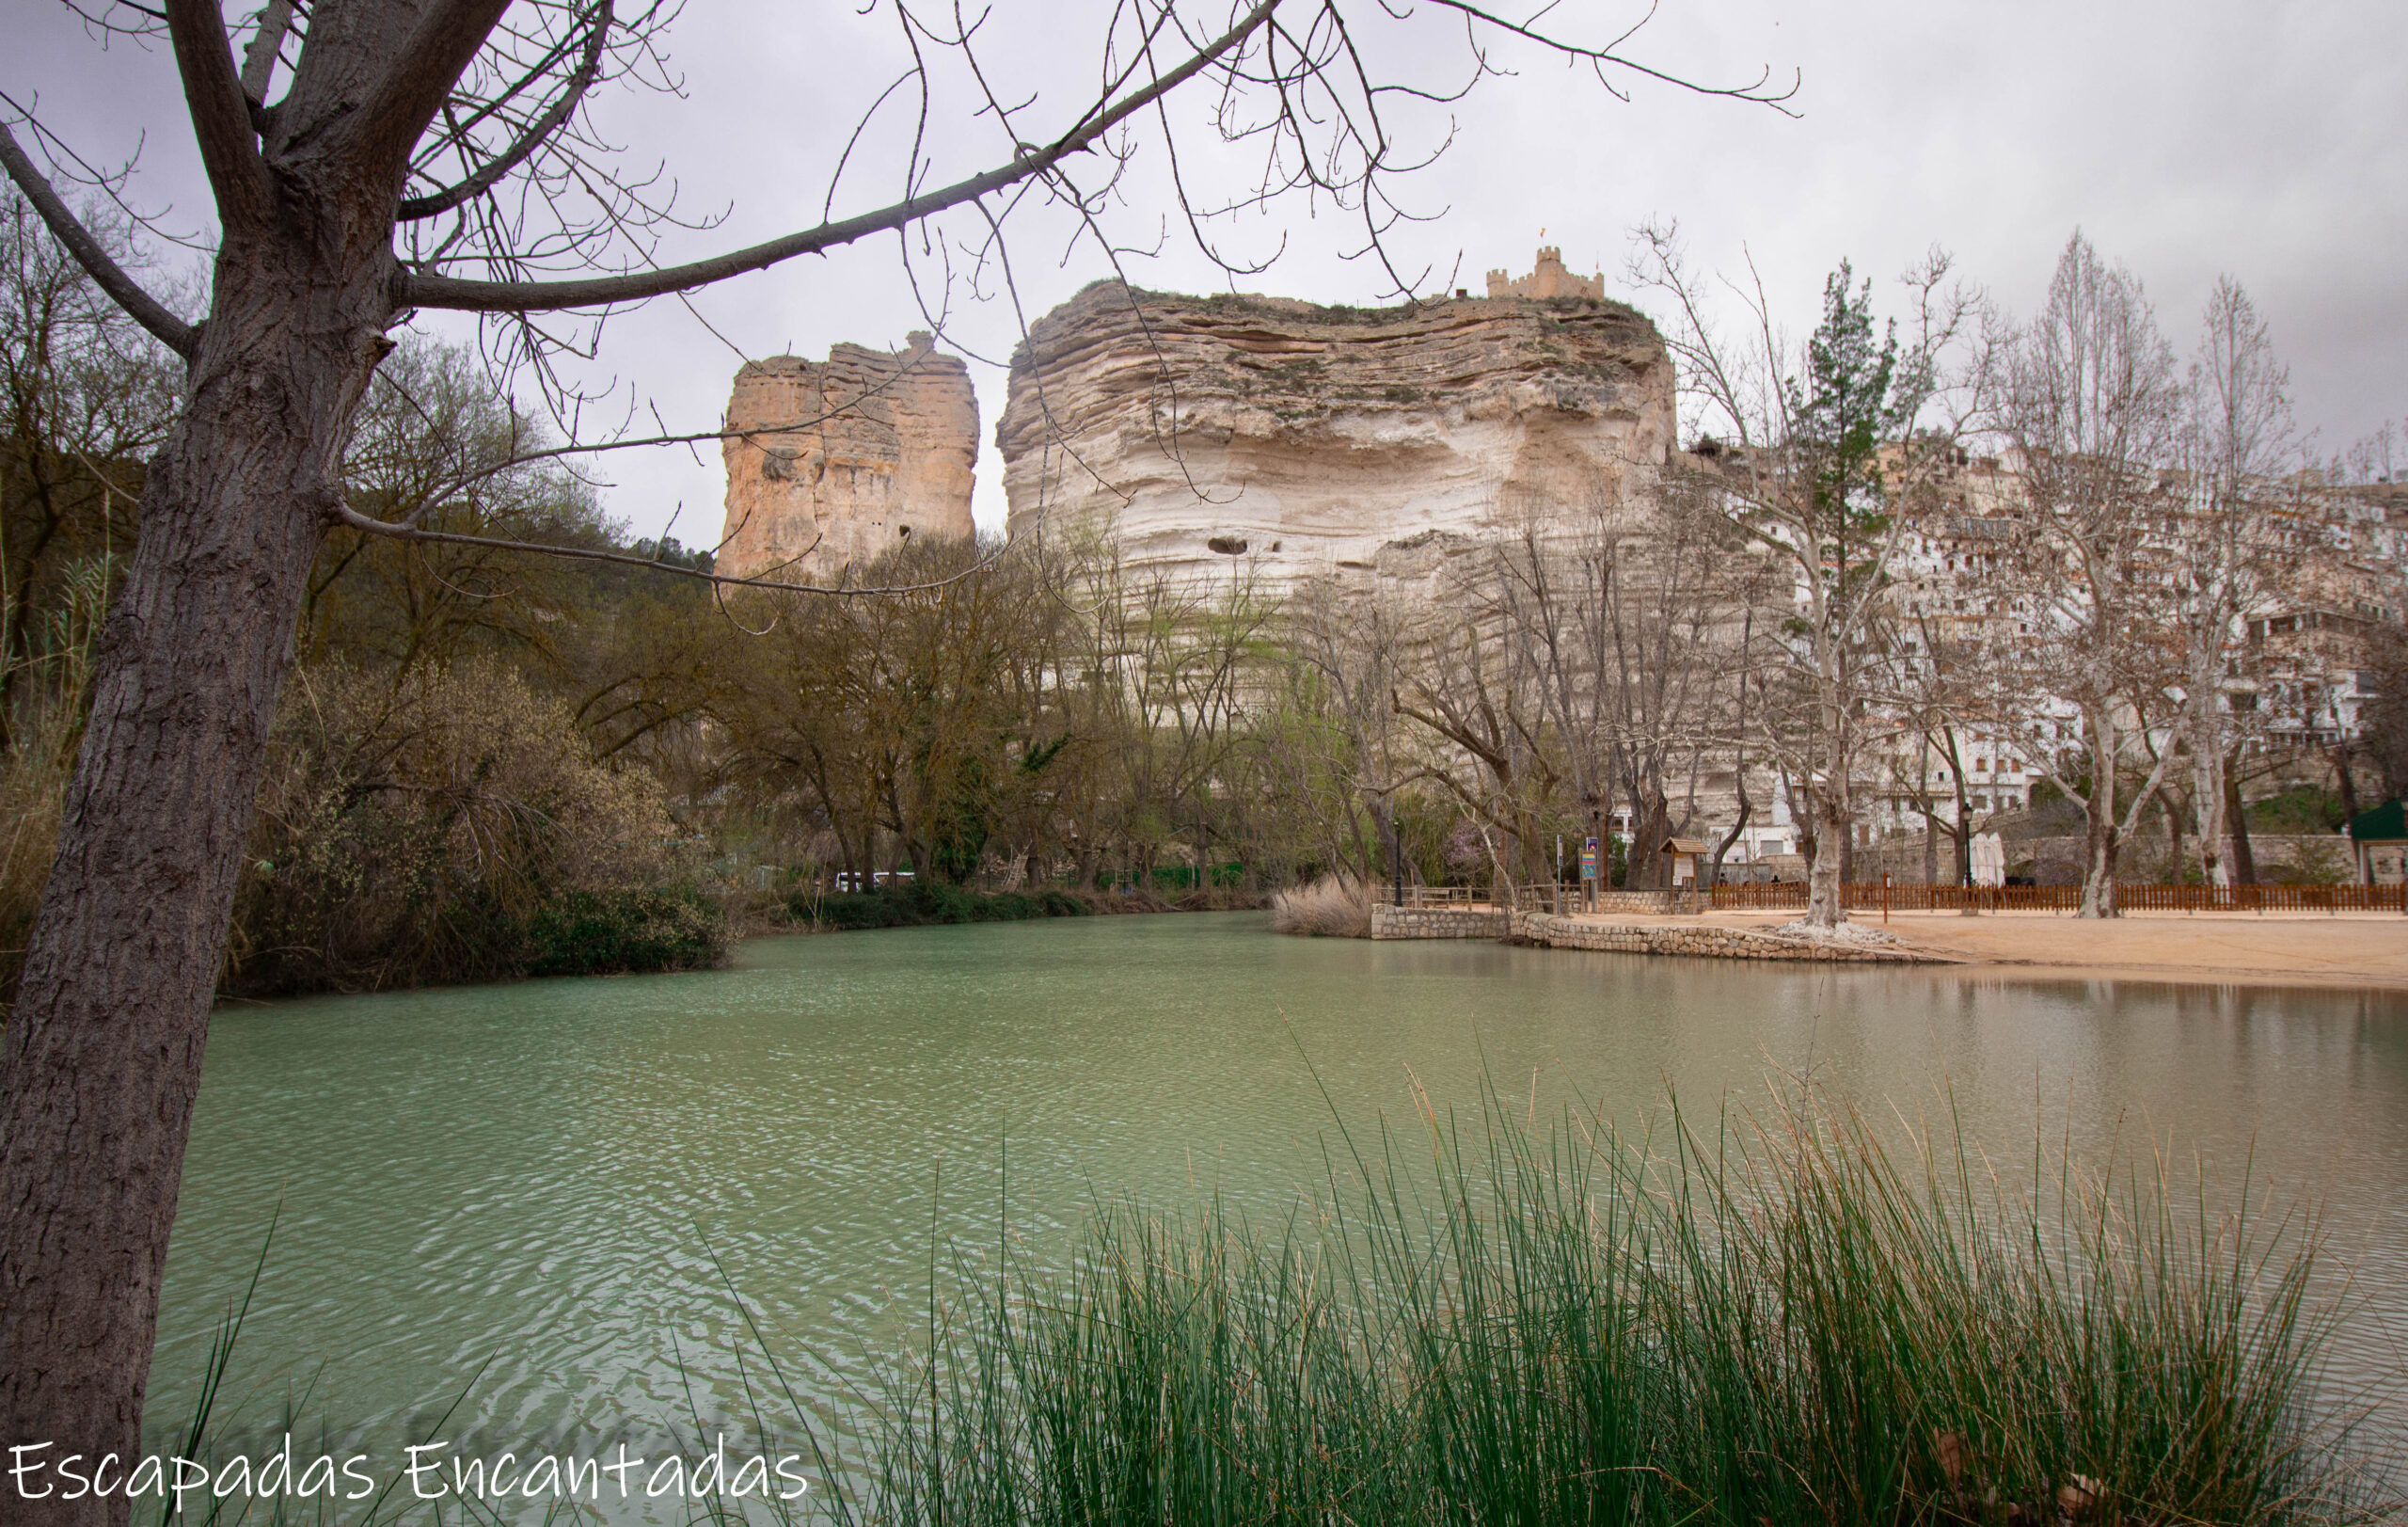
[0,216,390,1522]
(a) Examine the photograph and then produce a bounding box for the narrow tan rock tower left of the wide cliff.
[718,335,977,578]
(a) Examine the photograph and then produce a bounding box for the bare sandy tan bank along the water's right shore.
[1531,913,2408,990]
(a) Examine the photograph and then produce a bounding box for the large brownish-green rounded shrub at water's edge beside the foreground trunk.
[222,660,722,997]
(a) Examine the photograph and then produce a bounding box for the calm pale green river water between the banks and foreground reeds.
[151,913,2408,1503]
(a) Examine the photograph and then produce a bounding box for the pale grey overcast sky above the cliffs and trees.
[19,0,2408,545]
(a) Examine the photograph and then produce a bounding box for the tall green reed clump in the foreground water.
[866,1083,2386,1527]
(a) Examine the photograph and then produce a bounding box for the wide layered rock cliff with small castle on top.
[994,273,1673,581]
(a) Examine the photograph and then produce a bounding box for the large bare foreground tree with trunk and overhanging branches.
[0,0,1800,1483]
